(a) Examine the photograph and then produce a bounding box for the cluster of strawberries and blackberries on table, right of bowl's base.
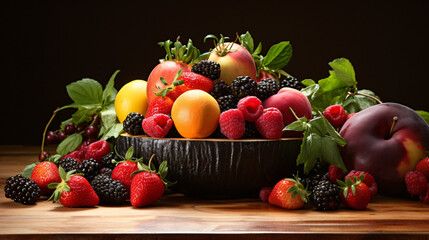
[259,161,378,211]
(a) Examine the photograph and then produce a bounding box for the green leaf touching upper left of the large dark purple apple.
[341,89,379,113]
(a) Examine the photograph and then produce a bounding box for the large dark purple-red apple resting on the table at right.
[340,103,429,196]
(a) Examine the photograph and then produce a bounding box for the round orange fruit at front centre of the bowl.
[171,90,220,138]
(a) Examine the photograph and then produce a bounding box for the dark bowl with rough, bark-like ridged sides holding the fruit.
[116,134,301,199]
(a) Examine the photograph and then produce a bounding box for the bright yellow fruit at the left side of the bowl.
[115,79,148,122]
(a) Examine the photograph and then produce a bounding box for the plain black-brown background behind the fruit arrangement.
[0,0,429,144]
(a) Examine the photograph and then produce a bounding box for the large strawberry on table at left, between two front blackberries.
[49,167,100,207]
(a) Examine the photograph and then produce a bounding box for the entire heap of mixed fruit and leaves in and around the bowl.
[5,32,429,211]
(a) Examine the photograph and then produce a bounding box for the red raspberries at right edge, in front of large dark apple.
[405,158,429,203]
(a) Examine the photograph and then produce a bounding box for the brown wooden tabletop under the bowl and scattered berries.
[0,146,429,240]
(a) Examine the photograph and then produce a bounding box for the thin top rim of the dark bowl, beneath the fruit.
[119,133,302,142]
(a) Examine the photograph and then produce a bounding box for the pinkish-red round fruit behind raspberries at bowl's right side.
[262,88,312,137]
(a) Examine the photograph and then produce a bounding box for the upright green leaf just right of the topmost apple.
[262,41,292,69]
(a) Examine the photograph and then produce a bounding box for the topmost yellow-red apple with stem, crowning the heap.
[208,42,256,85]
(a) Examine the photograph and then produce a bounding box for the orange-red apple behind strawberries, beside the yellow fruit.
[146,60,192,104]
